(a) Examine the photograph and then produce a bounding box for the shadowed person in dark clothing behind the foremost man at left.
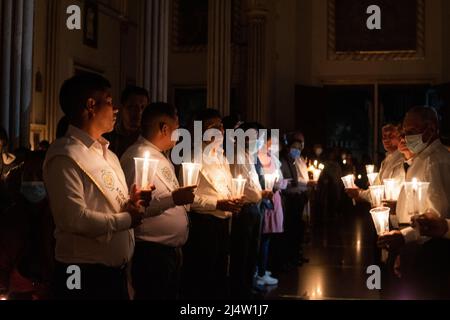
[0,152,54,300]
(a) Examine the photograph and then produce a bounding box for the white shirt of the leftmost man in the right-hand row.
[359,150,405,202]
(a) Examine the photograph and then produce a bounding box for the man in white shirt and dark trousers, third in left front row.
[183,109,242,300]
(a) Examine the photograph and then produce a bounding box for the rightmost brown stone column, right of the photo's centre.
[247,0,268,124]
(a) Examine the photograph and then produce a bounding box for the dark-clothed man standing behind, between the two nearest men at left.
[104,86,150,159]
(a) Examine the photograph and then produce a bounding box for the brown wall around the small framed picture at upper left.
[32,0,139,139]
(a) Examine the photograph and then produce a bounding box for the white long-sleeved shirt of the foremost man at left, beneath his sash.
[44,126,134,267]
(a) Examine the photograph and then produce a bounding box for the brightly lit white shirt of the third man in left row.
[191,149,232,219]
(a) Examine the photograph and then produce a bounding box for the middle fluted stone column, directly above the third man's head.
[207,0,231,116]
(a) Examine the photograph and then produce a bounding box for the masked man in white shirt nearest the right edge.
[379,107,450,297]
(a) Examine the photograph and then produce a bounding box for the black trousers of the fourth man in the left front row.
[230,205,262,299]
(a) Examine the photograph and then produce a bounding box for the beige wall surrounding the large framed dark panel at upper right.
[273,0,450,130]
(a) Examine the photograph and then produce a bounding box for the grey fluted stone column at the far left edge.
[0,0,34,148]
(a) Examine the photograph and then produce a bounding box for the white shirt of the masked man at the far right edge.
[397,140,450,242]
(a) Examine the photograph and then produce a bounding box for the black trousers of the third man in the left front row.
[182,212,229,300]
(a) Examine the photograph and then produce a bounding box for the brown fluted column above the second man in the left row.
[144,0,169,102]
